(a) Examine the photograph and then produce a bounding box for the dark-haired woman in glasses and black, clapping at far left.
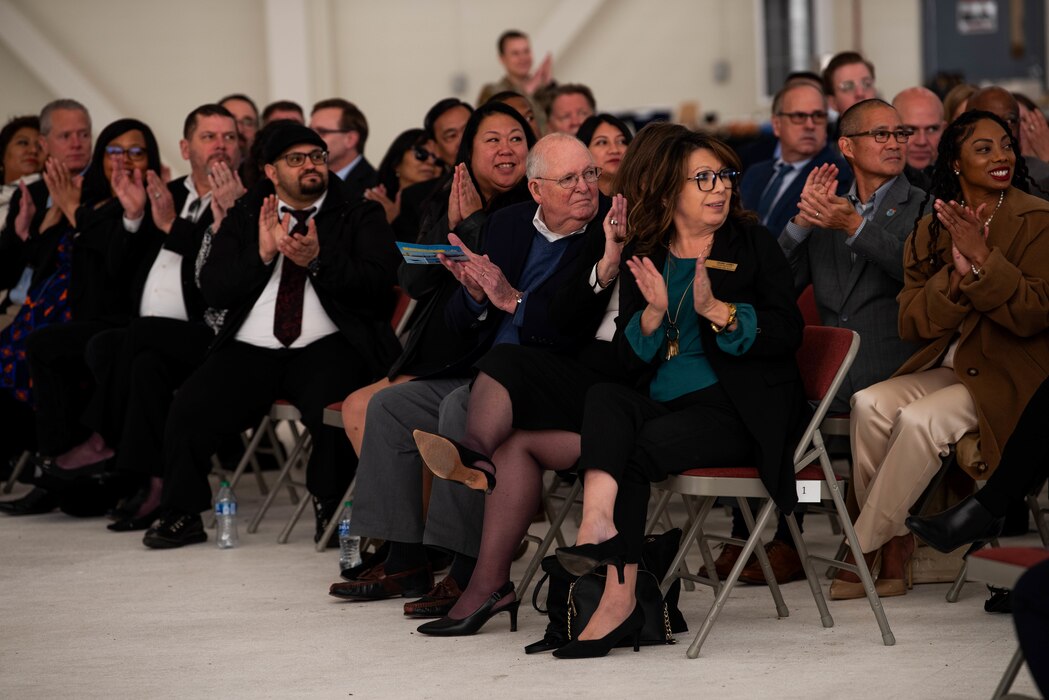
[0,120,160,478]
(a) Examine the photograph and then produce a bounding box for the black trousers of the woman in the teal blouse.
[579,384,754,561]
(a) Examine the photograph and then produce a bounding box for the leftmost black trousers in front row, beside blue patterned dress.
[25,321,113,457]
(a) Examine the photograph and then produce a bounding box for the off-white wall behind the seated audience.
[0,0,921,172]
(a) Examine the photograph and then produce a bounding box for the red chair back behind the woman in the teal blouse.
[794,325,859,470]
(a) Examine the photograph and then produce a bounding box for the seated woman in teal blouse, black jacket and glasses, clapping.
[555,124,811,658]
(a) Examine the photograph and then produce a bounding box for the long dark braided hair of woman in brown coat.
[911,109,1030,273]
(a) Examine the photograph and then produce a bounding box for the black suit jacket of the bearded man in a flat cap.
[200,174,401,378]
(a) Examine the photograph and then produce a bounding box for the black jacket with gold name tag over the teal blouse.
[617,222,812,512]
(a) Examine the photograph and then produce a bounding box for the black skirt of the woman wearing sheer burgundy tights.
[474,340,627,432]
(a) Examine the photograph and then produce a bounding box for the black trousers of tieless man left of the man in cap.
[84,317,215,476]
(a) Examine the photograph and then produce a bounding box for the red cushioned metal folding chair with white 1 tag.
[650,325,896,658]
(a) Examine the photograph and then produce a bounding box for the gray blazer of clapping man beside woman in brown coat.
[779,175,932,412]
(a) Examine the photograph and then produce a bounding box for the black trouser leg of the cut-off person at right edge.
[976,380,1049,517]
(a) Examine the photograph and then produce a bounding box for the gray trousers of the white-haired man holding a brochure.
[349,379,485,557]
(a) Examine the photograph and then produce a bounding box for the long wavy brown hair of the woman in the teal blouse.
[613,122,756,256]
